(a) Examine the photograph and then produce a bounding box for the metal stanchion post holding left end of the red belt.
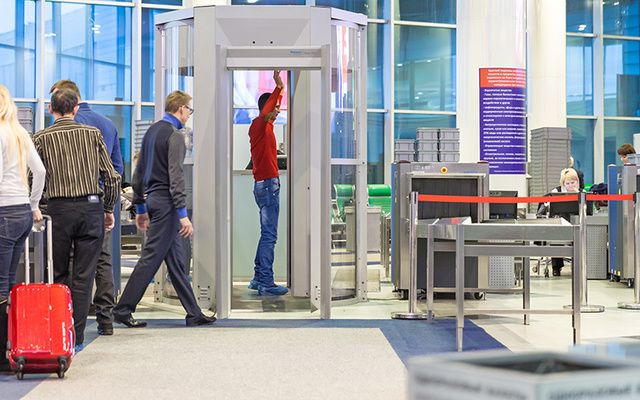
[391,192,427,319]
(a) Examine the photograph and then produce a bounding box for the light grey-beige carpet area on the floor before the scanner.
[0,327,406,400]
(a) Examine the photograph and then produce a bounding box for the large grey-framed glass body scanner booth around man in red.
[156,6,367,318]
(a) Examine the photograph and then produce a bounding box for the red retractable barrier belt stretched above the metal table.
[418,194,633,204]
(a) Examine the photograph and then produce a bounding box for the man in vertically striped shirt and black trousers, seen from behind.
[33,89,120,350]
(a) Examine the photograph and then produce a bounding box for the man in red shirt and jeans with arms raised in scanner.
[249,71,289,296]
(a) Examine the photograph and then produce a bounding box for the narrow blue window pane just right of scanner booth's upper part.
[367,24,387,108]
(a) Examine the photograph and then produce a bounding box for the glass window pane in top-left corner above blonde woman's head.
[0,1,36,98]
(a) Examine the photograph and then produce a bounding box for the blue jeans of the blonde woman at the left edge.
[0,204,33,300]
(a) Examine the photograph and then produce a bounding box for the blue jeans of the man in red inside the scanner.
[253,178,280,286]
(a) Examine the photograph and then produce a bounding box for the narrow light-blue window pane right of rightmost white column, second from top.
[566,36,593,115]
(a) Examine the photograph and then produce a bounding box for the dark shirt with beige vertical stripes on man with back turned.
[33,117,120,213]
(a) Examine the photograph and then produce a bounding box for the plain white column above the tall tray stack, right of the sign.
[527,0,567,132]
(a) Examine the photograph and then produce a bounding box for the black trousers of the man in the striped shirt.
[48,197,104,344]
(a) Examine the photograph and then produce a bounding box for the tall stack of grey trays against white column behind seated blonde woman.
[529,128,571,202]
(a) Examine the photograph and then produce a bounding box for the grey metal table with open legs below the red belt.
[417,217,581,351]
